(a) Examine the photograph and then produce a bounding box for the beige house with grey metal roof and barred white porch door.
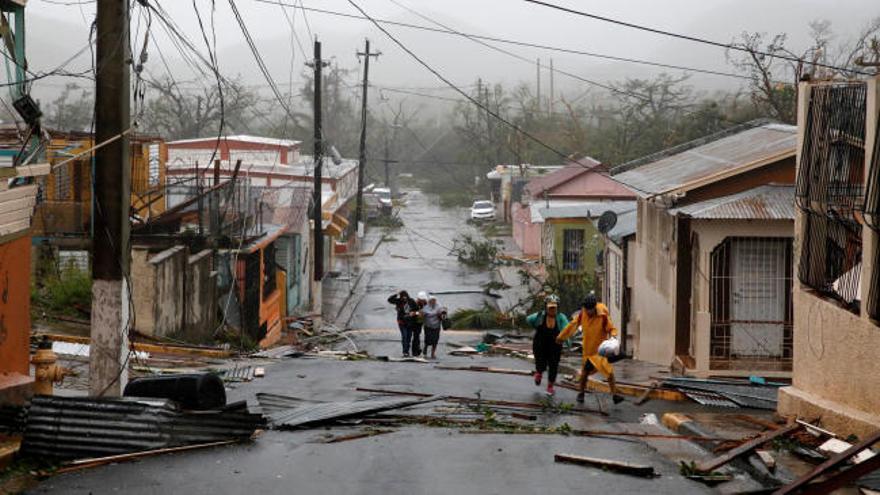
[614,122,797,376]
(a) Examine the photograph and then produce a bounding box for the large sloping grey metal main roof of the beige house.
[613,121,797,196]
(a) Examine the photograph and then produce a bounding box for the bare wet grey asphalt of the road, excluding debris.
[33,194,709,495]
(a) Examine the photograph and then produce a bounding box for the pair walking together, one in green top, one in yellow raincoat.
[526,292,623,404]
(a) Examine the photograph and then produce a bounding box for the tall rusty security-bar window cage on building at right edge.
[796,82,867,310]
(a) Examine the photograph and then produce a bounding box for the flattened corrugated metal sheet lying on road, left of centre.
[269,397,438,428]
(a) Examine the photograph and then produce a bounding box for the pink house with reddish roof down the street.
[513,158,636,257]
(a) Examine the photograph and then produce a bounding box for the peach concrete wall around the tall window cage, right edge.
[779,78,880,437]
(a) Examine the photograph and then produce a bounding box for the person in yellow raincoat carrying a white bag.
[556,292,623,404]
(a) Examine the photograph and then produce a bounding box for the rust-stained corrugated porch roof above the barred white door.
[670,184,795,220]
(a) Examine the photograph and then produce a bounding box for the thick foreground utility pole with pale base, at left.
[89,0,132,396]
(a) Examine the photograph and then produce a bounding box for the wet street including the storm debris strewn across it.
[13,191,844,494]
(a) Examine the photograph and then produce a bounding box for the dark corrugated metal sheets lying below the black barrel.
[21,396,265,459]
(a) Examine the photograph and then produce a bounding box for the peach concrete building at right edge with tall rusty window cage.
[779,78,880,438]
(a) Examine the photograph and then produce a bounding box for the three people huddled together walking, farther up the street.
[388,290,448,359]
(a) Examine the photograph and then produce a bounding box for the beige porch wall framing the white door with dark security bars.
[691,220,794,377]
